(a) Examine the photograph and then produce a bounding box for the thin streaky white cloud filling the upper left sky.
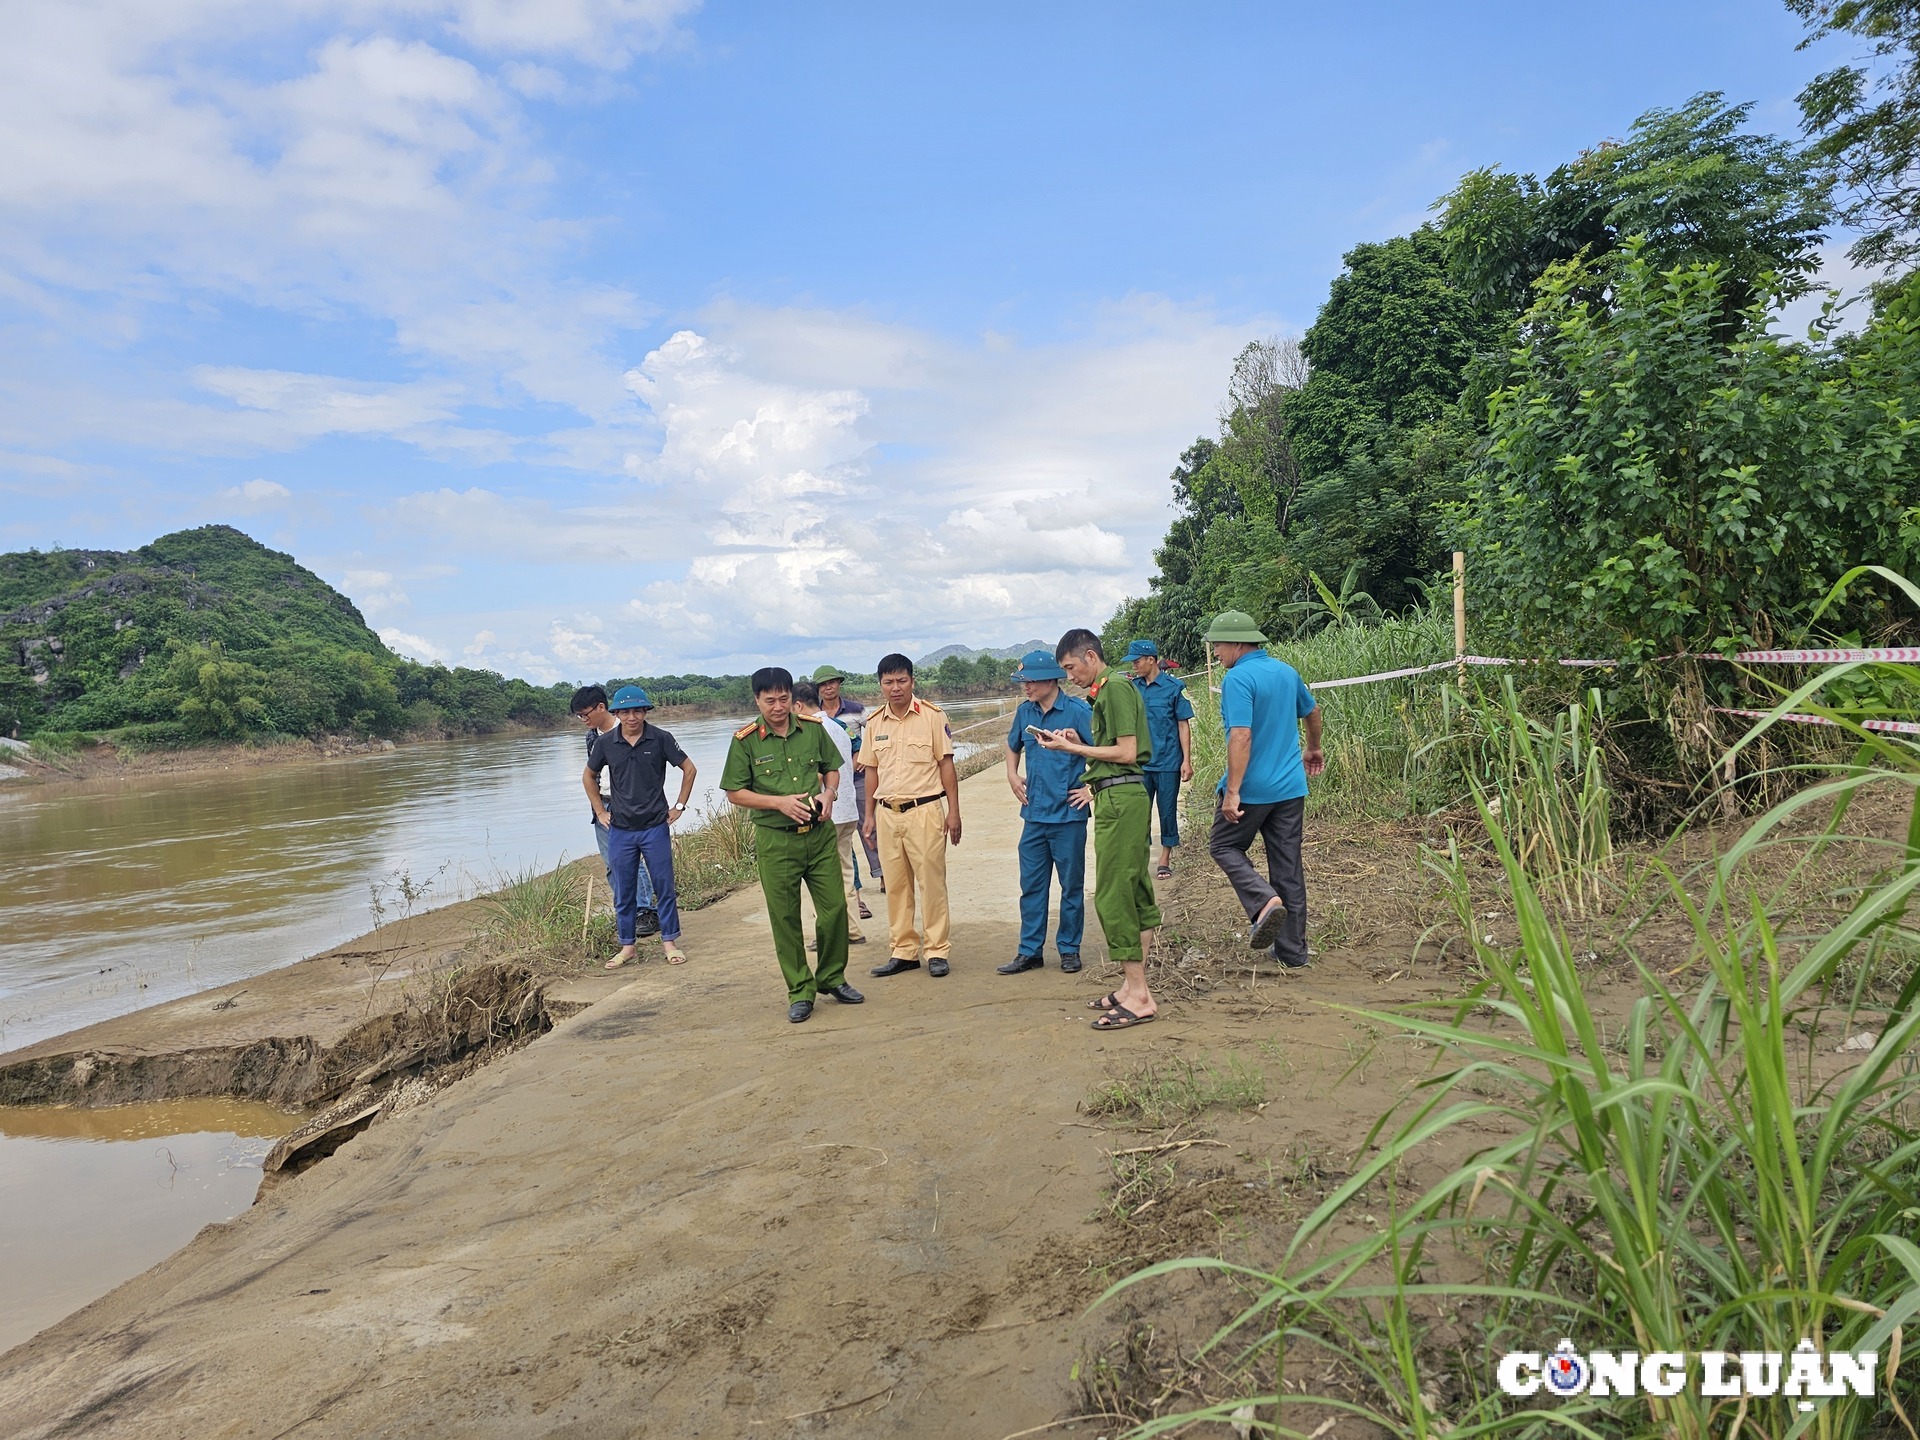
[0,0,691,463]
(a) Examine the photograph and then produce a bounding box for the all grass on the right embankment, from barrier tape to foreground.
[1110,625,1920,1440]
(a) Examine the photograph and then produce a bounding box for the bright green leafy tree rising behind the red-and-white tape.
[1473,240,1920,659]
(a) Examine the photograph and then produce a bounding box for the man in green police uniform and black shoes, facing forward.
[720,666,866,1025]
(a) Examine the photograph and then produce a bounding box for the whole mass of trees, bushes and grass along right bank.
[1083,16,1920,1440]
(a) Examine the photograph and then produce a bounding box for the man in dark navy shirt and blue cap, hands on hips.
[580,685,699,970]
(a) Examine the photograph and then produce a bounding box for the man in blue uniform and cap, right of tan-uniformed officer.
[1000,651,1092,975]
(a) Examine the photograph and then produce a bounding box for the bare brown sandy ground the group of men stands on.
[0,770,1482,1440]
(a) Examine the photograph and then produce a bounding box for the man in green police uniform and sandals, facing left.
[1035,630,1160,1029]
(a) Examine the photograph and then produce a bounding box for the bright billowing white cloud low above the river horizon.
[374,298,1273,676]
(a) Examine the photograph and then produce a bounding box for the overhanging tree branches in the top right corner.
[1788,0,1920,267]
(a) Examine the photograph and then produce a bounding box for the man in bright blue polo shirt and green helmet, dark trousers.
[1206,611,1327,970]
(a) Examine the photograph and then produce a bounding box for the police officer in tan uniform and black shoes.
[864,655,960,979]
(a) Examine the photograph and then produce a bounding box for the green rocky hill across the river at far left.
[0,524,566,745]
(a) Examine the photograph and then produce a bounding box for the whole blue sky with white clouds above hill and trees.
[0,0,1847,682]
